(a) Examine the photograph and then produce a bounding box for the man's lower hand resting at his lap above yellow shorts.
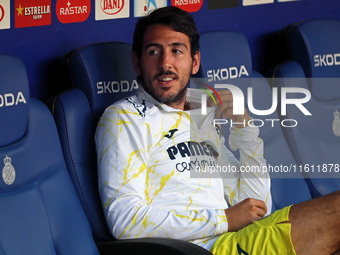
[224,198,267,232]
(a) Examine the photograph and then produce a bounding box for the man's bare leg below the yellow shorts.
[289,191,340,255]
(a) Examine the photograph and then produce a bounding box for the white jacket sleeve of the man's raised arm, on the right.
[221,126,272,215]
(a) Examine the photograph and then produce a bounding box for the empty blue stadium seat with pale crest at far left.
[0,55,98,255]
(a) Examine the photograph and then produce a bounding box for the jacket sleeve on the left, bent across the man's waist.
[95,107,228,240]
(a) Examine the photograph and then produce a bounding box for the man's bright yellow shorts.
[210,206,296,255]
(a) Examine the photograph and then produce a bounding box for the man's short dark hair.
[132,6,200,60]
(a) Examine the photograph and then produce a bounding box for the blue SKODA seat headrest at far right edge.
[287,19,340,100]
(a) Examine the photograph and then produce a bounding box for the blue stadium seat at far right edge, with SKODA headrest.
[271,19,340,197]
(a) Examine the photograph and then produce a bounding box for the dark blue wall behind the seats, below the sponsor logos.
[0,0,340,100]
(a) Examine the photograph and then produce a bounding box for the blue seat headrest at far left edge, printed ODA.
[0,54,29,147]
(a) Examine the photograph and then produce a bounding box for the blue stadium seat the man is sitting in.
[52,42,211,254]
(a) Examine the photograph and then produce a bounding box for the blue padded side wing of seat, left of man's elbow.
[53,88,112,241]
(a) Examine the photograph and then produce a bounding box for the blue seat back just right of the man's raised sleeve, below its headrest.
[250,70,312,209]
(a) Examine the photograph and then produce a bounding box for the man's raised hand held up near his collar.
[207,90,250,128]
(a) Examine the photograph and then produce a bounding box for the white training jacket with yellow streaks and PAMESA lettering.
[95,88,271,249]
